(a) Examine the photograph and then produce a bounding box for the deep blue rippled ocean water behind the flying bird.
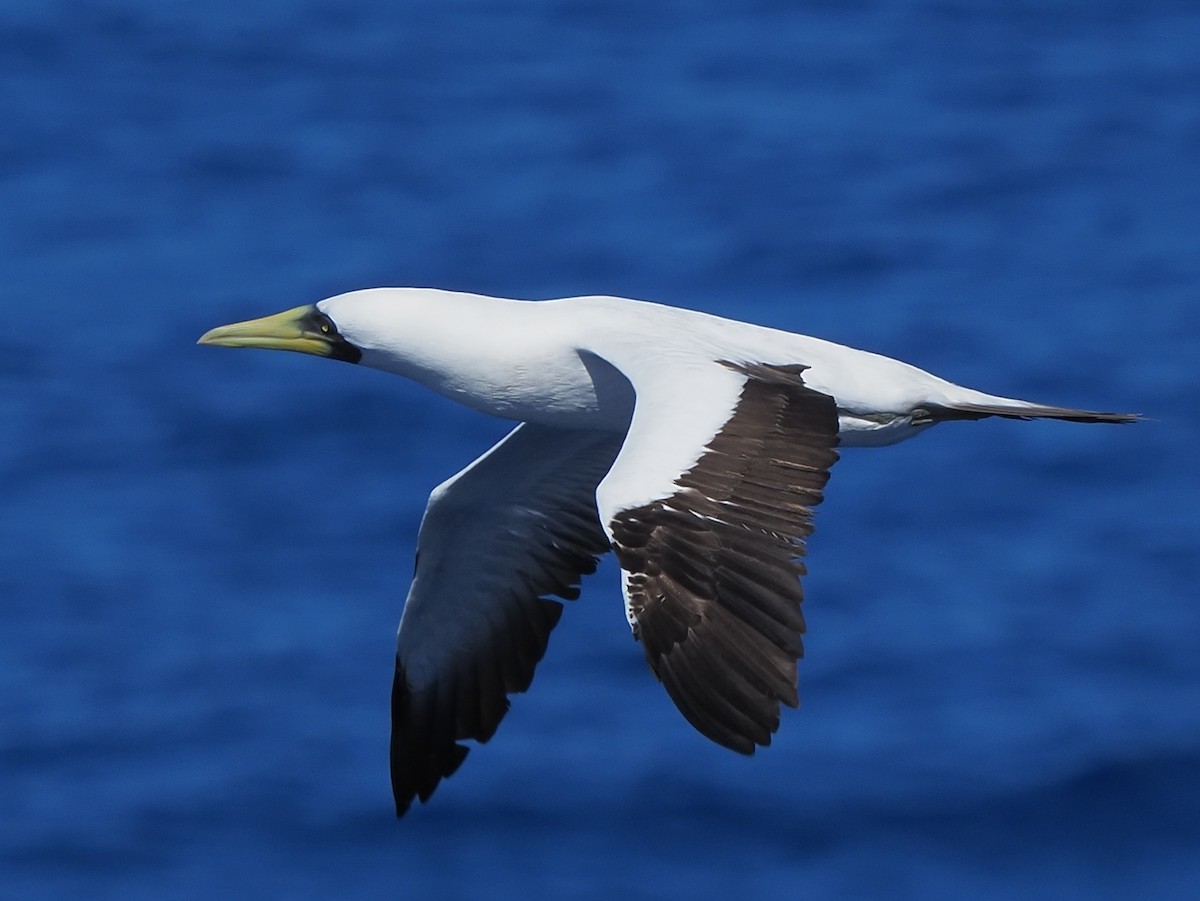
[0,0,1200,899]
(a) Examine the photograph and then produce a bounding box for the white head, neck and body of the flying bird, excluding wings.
[318,288,1033,445]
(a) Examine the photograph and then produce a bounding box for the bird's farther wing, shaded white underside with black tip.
[391,424,622,815]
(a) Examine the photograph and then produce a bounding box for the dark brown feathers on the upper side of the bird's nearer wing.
[602,364,838,753]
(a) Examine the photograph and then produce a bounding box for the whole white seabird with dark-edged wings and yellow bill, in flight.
[199,288,1138,815]
